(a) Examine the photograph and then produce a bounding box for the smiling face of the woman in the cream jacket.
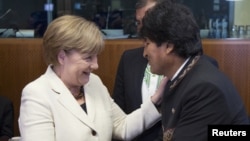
[58,50,98,87]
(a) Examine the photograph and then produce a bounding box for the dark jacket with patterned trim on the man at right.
[162,56,249,141]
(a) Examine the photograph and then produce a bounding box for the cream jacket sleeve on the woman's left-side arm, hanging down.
[18,86,55,141]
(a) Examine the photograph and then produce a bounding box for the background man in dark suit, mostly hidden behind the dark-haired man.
[112,0,218,141]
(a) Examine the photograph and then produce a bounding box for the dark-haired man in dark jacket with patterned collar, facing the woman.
[139,2,249,141]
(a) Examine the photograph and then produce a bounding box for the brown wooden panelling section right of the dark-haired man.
[203,39,250,115]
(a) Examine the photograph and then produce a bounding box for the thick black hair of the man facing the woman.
[139,1,202,58]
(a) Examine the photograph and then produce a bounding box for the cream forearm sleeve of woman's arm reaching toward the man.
[112,99,161,140]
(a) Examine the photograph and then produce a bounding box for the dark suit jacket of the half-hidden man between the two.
[112,47,162,141]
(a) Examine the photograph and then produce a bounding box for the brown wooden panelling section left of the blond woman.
[0,39,46,135]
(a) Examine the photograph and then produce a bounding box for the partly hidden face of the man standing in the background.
[135,2,156,32]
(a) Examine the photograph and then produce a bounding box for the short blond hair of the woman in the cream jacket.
[43,15,104,65]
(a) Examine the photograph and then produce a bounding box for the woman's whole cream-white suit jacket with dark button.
[19,66,160,141]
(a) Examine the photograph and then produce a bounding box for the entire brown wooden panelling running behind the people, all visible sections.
[0,38,250,135]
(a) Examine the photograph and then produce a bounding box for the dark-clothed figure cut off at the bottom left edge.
[0,96,14,141]
